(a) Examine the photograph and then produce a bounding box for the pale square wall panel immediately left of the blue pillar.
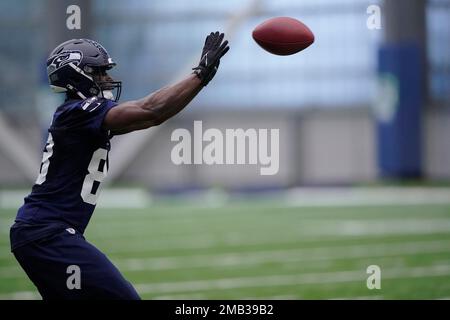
[298,110,377,184]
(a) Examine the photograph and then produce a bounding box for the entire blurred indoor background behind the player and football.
[0,0,450,299]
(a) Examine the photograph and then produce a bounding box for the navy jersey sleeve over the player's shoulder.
[57,97,117,136]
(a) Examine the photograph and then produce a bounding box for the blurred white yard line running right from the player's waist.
[0,218,450,259]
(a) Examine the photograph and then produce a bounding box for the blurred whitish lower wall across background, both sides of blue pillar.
[0,107,450,189]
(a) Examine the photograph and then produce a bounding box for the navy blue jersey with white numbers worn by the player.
[11,97,116,248]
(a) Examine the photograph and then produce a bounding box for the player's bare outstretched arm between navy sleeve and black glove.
[103,74,203,135]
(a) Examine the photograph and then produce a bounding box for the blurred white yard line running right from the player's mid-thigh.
[0,241,450,279]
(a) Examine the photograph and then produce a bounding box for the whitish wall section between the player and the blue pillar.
[111,110,376,188]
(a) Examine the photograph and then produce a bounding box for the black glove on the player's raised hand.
[192,31,230,86]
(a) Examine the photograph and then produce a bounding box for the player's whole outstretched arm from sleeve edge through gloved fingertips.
[103,32,229,134]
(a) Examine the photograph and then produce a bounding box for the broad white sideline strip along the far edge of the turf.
[0,187,450,209]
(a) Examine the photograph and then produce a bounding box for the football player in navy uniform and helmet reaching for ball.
[10,32,229,300]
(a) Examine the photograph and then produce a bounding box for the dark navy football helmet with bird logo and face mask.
[47,39,122,101]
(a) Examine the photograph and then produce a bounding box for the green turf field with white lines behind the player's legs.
[0,202,450,299]
